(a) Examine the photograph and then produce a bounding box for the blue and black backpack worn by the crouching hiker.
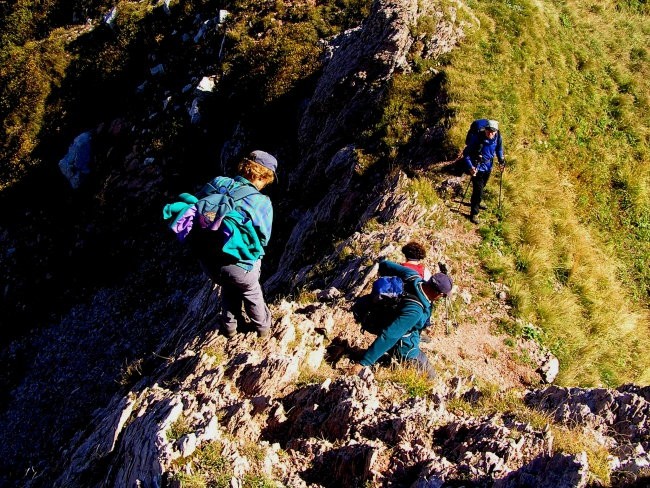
[352,275,420,335]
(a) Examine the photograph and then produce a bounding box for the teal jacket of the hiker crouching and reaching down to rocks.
[360,261,432,366]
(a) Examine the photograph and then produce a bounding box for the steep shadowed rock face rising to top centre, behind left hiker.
[264,0,462,292]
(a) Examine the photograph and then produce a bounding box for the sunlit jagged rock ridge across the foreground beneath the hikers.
[55,185,650,487]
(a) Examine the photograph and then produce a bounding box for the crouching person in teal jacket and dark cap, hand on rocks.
[351,261,453,379]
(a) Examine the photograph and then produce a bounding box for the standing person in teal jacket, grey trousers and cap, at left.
[190,151,278,338]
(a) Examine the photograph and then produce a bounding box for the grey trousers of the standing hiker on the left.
[217,260,271,335]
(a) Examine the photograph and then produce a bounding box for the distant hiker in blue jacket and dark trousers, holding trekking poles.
[463,119,505,224]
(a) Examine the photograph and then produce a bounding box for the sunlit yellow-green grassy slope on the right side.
[446,0,650,386]
